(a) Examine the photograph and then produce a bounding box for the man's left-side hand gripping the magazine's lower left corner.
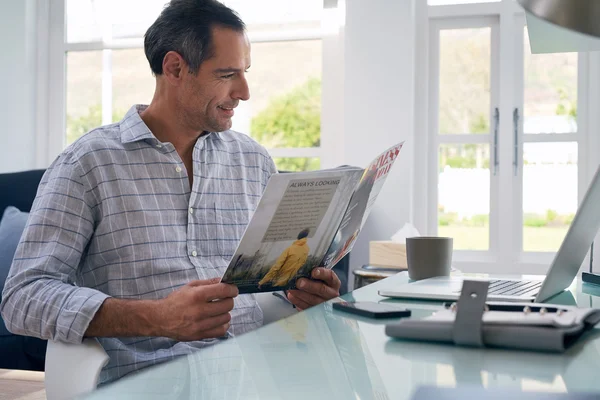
[156,278,238,341]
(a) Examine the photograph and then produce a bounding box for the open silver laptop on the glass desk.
[379,167,600,303]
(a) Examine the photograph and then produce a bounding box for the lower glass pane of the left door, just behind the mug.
[438,144,490,250]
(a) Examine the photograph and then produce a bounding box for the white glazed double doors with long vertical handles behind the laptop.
[428,0,588,273]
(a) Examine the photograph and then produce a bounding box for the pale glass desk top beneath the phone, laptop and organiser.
[82,272,600,400]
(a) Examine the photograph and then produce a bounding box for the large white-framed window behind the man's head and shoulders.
[58,0,323,170]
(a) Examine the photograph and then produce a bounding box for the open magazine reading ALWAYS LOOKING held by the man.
[221,142,404,293]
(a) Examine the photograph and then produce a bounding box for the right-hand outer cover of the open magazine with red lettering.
[321,142,404,268]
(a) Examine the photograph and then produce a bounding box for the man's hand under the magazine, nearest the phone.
[287,268,342,310]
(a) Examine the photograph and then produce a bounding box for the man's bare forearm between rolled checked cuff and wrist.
[85,297,162,337]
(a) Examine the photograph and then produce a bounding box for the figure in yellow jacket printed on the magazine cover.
[258,229,310,289]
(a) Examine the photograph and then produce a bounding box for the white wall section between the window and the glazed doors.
[342,0,414,268]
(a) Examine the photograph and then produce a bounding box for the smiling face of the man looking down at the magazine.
[179,27,250,132]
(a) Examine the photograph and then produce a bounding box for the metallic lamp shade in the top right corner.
[517,0,600,38]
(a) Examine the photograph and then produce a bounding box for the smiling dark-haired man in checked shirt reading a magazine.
[1,0,340,383]
